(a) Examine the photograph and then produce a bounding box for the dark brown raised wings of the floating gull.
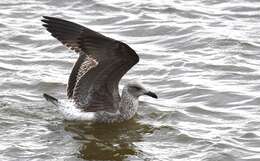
[42,16,139,111]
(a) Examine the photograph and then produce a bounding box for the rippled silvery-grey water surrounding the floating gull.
[0,0,260,161]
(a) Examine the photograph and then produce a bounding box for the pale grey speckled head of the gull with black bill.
[126,81,158,99]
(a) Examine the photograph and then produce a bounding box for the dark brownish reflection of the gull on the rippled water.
[65,119,153,161]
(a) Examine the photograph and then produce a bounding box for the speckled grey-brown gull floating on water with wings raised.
[42,16,157,123]
